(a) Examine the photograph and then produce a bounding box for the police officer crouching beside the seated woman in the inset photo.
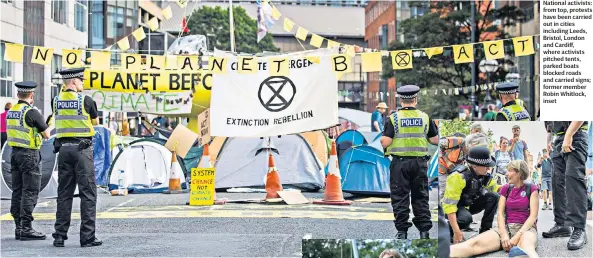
[441,146,500,244]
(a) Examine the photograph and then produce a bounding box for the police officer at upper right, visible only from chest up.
[496,82,531,121]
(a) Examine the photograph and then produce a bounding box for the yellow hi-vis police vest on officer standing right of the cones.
[385,109,430,157]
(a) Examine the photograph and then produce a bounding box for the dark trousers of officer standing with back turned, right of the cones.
[389,156,432,232]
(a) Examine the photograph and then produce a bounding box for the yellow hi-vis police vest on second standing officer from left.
[53,91,95,139]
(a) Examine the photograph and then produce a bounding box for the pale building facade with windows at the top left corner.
[0,0,88,116]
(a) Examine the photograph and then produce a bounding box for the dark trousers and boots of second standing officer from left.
[52,138,97,244]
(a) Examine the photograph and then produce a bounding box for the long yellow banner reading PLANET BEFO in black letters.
[84,69,212,92]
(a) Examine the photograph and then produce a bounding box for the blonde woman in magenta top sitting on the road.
[451,160,539,258]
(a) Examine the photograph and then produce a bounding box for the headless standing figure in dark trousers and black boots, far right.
[542,121,589,250]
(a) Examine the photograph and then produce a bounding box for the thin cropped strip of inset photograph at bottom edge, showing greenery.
[303,239,438,258]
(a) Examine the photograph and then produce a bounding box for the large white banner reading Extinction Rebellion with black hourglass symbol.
[210,49,338,137]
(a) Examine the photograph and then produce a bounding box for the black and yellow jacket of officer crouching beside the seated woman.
[441,165,500,214]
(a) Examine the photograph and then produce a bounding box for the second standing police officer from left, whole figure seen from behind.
[52,68,102,247]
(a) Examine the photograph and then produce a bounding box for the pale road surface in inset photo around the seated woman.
[464,200,593,257]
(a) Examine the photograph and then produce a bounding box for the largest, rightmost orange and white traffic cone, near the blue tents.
[313,140,352,205]
